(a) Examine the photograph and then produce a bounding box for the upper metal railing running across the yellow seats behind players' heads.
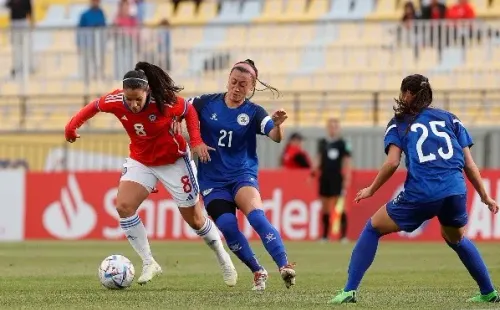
[0,21,500,95]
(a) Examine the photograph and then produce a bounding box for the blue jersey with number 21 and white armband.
[188,94,274,190]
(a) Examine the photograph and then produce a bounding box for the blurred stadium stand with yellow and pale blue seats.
[0,0,500,129]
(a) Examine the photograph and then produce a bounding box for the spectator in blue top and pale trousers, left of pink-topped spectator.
[77,0,106,81]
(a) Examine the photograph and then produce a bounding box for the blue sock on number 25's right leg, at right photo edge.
[446,237,495,295]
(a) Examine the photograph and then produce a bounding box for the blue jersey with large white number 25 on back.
[384,108,473,203]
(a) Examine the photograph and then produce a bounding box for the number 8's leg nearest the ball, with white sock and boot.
[116,158,162,284]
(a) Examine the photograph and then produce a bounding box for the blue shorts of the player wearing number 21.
[201,175,259,206]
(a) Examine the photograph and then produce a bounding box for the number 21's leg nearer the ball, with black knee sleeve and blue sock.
[205,200,268,291]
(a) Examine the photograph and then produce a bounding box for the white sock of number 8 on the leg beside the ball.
[120,213,153,265]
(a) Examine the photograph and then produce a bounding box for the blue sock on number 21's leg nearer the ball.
[215,213,263,273]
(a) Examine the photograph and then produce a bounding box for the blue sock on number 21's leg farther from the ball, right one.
[247,209,288,268]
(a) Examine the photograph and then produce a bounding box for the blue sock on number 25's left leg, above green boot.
[344,220,381,292]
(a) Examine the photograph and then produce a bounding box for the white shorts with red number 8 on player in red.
[120,155,200,207]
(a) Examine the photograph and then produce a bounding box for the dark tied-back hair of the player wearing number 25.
[393,74,432,122]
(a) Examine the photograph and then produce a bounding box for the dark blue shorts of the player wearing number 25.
[386,194,468,232]
